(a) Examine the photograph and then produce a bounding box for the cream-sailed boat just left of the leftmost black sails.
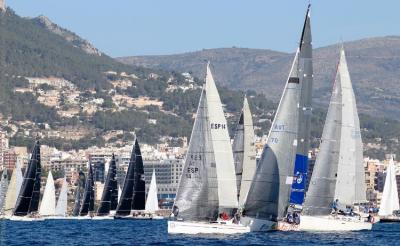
[4,162,24,218]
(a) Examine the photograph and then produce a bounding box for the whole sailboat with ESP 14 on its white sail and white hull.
[168,63,248,234]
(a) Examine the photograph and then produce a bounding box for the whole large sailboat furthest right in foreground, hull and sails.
[279,48,372,231]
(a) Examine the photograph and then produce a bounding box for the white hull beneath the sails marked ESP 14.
[168,221,250,234]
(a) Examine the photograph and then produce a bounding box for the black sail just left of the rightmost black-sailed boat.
[97,154,118,216]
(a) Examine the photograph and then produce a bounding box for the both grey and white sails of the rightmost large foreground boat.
[303,48,366,215]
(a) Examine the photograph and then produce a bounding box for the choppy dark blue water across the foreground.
[0,220,400,246]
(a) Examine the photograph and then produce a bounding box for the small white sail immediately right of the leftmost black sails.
[39,171,56,216]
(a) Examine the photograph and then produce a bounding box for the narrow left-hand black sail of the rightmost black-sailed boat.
[116,139,141,216]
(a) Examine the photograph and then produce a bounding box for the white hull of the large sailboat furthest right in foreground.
[277,215,372,231]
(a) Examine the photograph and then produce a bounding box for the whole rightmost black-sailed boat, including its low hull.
[114,138,150,219]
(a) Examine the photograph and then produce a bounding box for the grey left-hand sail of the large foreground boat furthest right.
[303,66,342,216]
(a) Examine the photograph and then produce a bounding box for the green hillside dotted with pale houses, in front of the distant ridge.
[0,9,400,160]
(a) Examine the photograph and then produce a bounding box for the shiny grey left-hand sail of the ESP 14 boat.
[174,88,219,221]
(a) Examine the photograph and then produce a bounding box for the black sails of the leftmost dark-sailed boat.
[14,141,41,216]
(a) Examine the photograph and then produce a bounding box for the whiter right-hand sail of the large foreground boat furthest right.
[335,48,366,205]
